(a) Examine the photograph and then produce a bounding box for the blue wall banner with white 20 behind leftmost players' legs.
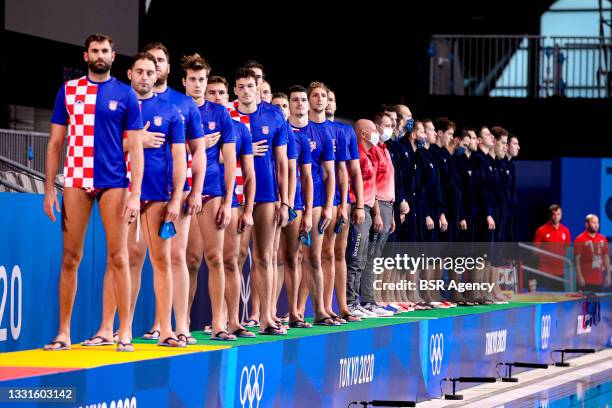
[0,193,154,352]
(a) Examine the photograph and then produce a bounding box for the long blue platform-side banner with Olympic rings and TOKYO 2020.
[0,296,612,408]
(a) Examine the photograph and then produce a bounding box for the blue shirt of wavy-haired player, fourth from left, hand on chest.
[199,101,236,197]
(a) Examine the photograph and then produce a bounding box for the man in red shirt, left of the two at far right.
[533,204,572,291]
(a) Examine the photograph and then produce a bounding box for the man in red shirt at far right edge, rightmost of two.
[574,214,612,292]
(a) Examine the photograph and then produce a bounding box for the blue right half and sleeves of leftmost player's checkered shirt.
[51,77,143,188]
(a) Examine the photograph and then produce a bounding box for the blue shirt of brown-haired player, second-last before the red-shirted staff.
[293,122,335,207]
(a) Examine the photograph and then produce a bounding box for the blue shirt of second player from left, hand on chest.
[140,96,185,201]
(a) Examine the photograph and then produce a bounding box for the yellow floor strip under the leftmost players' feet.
[0,344,228,368]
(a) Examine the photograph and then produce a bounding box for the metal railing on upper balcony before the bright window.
[429,35,612,98]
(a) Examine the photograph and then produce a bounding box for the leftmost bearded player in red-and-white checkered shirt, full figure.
[44,34,144,351]
